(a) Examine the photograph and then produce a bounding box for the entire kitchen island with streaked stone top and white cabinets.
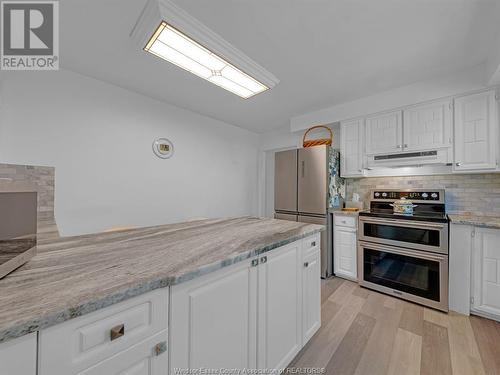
[0,217,323,375]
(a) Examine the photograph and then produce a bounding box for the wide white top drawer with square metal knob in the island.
[40,288,168,375]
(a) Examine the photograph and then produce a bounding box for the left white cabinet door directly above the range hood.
[365,111,403,155]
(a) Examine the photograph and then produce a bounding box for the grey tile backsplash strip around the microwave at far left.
[0,163,59,239]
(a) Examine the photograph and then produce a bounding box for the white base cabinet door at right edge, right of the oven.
[472,228,500,319]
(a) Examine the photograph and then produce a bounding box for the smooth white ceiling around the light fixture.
[60,0,500,132]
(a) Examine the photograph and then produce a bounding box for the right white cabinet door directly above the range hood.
[403,100,453,151]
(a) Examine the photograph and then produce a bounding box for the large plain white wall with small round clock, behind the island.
[0,71,259,235]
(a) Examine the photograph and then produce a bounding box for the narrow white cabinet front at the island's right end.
[302,242,321,344]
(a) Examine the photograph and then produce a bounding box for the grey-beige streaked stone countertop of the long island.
[0,217,324,342]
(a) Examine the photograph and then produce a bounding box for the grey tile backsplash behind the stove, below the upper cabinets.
[346,173,500,216]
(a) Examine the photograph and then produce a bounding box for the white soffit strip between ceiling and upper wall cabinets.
[290,64,487,132]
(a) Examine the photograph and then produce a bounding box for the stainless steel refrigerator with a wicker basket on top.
[274,145,339,277]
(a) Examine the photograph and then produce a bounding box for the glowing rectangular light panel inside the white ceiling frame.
[144,22,269,99]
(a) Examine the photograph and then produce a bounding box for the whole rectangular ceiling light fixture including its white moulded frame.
[130,0,279,98]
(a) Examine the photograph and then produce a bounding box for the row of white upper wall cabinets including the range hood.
[340,89,500,177]
